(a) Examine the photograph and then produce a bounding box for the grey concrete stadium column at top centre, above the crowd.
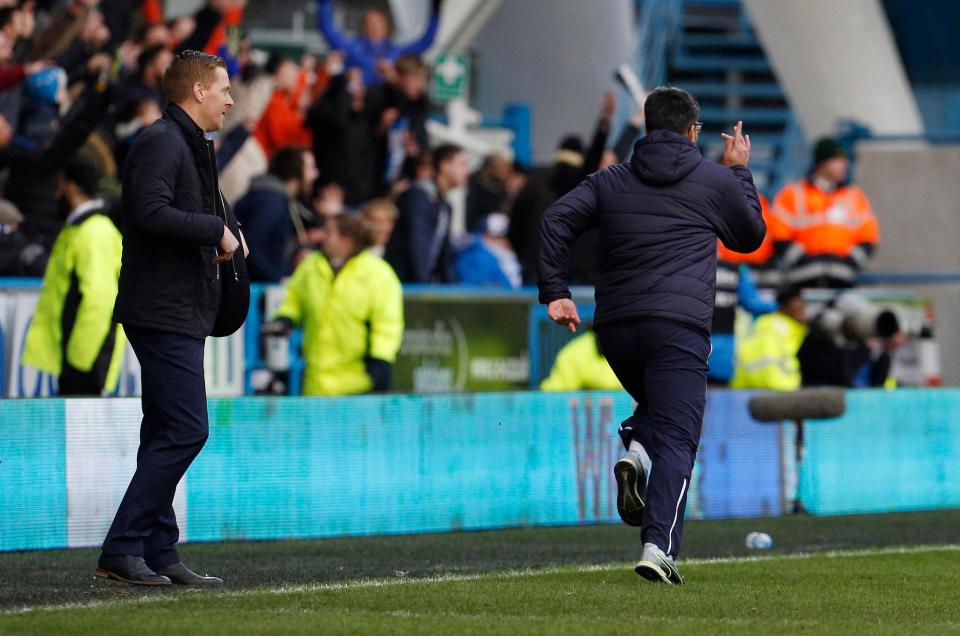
[471,0,634,162]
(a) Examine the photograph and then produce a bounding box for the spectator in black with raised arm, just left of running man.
[507,93,616,284]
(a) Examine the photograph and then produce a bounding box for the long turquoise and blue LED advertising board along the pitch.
[0,389,960,550]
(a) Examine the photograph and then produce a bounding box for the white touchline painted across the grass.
[7,543,960,616]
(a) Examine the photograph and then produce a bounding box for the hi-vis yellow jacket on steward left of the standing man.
[23,210,126,391]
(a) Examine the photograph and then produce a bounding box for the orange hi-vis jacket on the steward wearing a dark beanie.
[767,179,880,284]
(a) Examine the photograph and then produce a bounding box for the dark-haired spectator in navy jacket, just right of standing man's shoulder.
[234,146,317,283]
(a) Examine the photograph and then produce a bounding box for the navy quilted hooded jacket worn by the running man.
[538,130,766,333]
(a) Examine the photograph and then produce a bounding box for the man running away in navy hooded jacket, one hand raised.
[538,88,766,583]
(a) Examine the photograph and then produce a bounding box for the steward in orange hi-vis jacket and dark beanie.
[770,137,879,288]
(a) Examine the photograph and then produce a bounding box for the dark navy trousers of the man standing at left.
[103,327,208,569]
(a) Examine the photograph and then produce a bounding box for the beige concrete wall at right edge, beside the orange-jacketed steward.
[856,142,960,385]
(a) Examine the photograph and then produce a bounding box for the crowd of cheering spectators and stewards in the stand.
[0,0,878,392]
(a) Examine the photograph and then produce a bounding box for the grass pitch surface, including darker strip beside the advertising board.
[0,511,960,635]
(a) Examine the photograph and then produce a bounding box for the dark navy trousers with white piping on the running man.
[597,320,710,556]
